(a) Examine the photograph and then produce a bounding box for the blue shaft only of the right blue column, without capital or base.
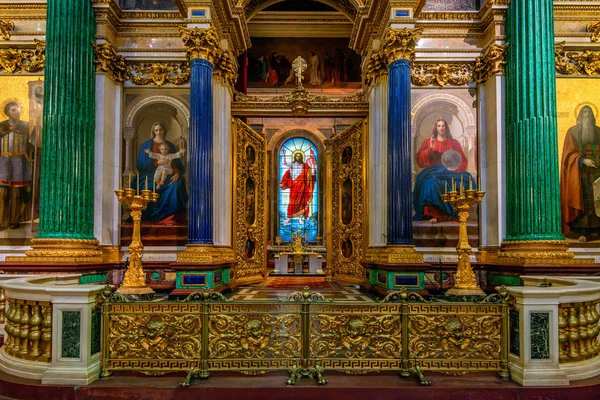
[387,59,413,245]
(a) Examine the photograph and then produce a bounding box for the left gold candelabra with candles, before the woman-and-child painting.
[115,175,158,294]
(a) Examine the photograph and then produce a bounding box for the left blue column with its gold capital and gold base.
[178,26,223,263]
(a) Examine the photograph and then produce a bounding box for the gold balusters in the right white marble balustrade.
[558,300,600,363]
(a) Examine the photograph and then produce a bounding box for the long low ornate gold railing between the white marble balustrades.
[101,291,508,384]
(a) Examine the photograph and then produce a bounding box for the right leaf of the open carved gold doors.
[331,121,366,283]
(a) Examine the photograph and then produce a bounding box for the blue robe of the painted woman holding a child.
[131,139,187,222]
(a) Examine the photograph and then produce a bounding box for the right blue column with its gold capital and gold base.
[381,28,423,263]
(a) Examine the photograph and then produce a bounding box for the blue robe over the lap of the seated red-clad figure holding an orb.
[413,165,477,221]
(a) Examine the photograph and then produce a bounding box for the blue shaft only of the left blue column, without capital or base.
[188,58,213,244]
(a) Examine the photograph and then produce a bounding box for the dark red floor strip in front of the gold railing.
[0,371,600,400]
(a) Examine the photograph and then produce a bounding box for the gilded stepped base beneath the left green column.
[6,239,102,263]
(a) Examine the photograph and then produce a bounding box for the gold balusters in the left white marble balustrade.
[3,298,52,362]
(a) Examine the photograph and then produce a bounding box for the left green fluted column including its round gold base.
[26,0,101,262]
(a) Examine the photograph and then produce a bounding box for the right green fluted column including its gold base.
[501,0,572,261]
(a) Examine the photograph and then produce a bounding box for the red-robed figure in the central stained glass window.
[280,149,317,223]
